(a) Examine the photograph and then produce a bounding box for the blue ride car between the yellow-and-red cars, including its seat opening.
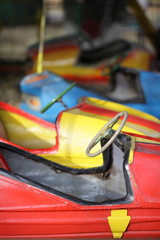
[20,68,160,122]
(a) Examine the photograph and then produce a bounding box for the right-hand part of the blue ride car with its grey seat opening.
[102,68,160,118]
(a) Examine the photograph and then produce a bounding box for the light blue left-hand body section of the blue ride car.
[20,71,103,122]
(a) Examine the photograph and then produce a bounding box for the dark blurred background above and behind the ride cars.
[0,0,160,106]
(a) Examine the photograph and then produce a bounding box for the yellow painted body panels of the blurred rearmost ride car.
[32,46,150,77]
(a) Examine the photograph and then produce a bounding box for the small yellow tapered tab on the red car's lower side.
[108,209,131,238]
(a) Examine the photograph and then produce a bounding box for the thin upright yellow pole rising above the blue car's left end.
[37,0,46,73]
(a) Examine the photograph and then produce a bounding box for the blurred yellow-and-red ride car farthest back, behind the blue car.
[27,35,155,87]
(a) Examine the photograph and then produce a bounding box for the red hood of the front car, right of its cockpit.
[130,139,160,204]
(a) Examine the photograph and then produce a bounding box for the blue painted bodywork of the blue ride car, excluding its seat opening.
[20,71,160,122]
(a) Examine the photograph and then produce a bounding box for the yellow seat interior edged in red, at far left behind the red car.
[0,110,56,149]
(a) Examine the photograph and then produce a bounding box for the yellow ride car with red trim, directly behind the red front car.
[0,98,160,167]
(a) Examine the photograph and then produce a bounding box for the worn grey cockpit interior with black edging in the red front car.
[0,134,132,205]
